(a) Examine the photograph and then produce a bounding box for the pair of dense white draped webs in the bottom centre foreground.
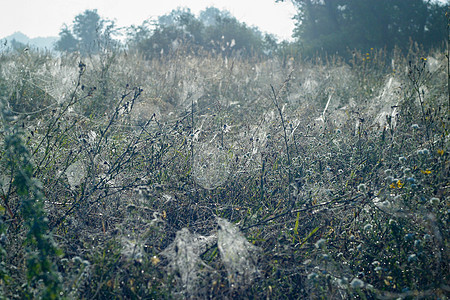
[161,218,259,296]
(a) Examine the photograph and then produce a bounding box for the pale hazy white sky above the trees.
[0,0,295,39]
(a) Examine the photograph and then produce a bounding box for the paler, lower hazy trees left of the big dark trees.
[56,7,278,58]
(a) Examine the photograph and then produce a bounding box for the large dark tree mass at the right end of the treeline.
[281,0,446,55]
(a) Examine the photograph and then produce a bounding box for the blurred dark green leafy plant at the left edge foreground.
[1,105,61,299]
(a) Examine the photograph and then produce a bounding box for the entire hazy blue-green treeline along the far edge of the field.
[51,0,448,59]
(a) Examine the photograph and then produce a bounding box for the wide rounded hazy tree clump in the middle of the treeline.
[129,7,276,57]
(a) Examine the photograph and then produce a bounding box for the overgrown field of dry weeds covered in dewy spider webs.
[0,47,450,299]
